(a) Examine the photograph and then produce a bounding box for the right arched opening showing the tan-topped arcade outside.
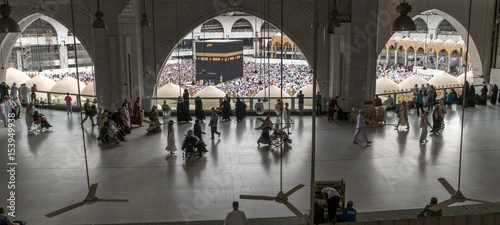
[377,10,477,96]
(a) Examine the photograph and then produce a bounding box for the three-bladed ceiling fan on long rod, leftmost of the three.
[45,0,128,218]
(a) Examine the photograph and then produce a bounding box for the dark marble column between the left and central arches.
[93,0,145,110]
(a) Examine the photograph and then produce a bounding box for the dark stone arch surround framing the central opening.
[143,1,316,96]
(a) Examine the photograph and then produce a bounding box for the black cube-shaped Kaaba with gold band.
[196,40,243,84]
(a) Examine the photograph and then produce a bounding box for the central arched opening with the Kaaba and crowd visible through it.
[156,14,312,110]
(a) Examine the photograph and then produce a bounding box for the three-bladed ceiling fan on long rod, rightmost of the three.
[429,0,500,211]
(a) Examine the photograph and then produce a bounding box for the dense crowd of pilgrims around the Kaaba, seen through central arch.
[158,59,312,96]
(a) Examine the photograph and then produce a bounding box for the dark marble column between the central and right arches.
[330,0,376,110]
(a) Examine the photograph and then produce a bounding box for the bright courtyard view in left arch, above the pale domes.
[8,14,94,84]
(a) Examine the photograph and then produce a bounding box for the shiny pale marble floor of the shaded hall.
[0,106,500,225]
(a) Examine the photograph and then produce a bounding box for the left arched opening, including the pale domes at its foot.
[2,13,95,104]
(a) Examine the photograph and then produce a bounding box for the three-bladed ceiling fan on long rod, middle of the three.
[240,0,305,217]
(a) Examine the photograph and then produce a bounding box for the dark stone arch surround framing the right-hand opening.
[377,0,495,80]
